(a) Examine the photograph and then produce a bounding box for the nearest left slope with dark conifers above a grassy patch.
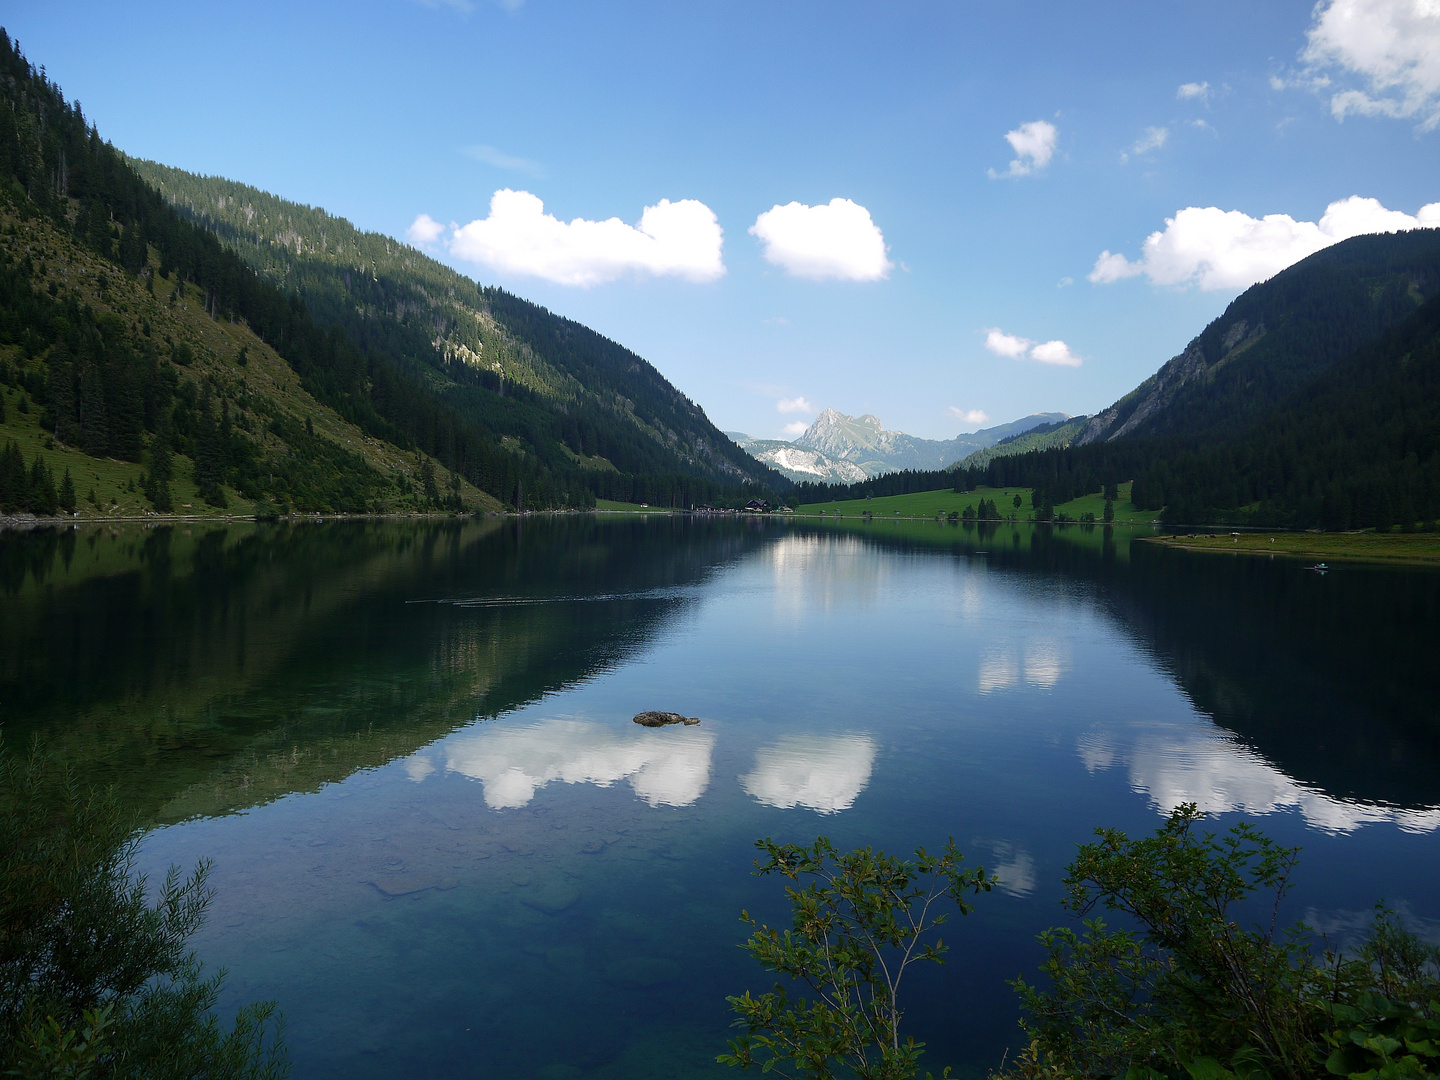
[0,32,498,516]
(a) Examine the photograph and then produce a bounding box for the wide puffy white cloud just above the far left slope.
[437,187,724,287]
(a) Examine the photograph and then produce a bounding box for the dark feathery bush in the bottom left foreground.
[0,749,289,1080]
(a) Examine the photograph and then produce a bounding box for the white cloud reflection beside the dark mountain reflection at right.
[1077,721,1440,834]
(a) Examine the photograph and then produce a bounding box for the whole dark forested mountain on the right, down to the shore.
[938,229,1440,530]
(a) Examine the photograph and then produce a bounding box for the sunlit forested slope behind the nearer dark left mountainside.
[131,161,788,503]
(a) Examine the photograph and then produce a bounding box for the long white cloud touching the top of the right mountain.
[1090,194,1440,289]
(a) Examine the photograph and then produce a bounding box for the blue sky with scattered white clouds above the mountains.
[0,0,1440,438]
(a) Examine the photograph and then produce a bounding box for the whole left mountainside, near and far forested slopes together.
[0,32,788,513]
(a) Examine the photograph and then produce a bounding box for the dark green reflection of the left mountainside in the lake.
[0,516,762,819]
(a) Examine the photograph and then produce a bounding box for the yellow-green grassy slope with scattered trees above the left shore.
[0,189,500,518]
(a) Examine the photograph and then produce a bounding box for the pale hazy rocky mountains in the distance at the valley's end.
[726,409,1070,484]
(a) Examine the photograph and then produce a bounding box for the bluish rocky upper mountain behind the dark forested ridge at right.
[1076,229,1440,445]
